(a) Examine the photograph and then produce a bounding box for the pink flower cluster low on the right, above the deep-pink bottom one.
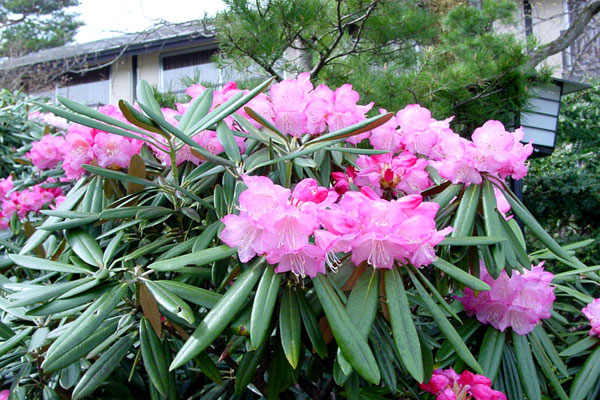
[460,262,555,335]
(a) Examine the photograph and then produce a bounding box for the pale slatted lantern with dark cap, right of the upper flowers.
[516,79,591,157]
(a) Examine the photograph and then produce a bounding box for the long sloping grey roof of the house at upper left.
[0,21,216,70]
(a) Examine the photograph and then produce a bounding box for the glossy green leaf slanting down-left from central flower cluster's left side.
[170,258,265,370]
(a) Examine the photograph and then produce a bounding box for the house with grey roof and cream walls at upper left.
[0,22,225,106]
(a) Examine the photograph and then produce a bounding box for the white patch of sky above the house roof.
[70,0,224,43]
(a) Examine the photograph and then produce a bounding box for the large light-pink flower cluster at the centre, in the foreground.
[221,176,452,277]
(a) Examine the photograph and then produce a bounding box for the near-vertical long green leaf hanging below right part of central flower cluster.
[385,267,424,382]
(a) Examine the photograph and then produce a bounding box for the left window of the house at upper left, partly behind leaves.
[56,67,110,106]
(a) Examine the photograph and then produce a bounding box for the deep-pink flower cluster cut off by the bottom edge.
[419,368,506,400]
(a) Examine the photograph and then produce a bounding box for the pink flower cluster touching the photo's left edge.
[0,176,65,229]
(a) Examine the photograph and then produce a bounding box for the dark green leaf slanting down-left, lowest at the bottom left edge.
[73,334,135,400]
